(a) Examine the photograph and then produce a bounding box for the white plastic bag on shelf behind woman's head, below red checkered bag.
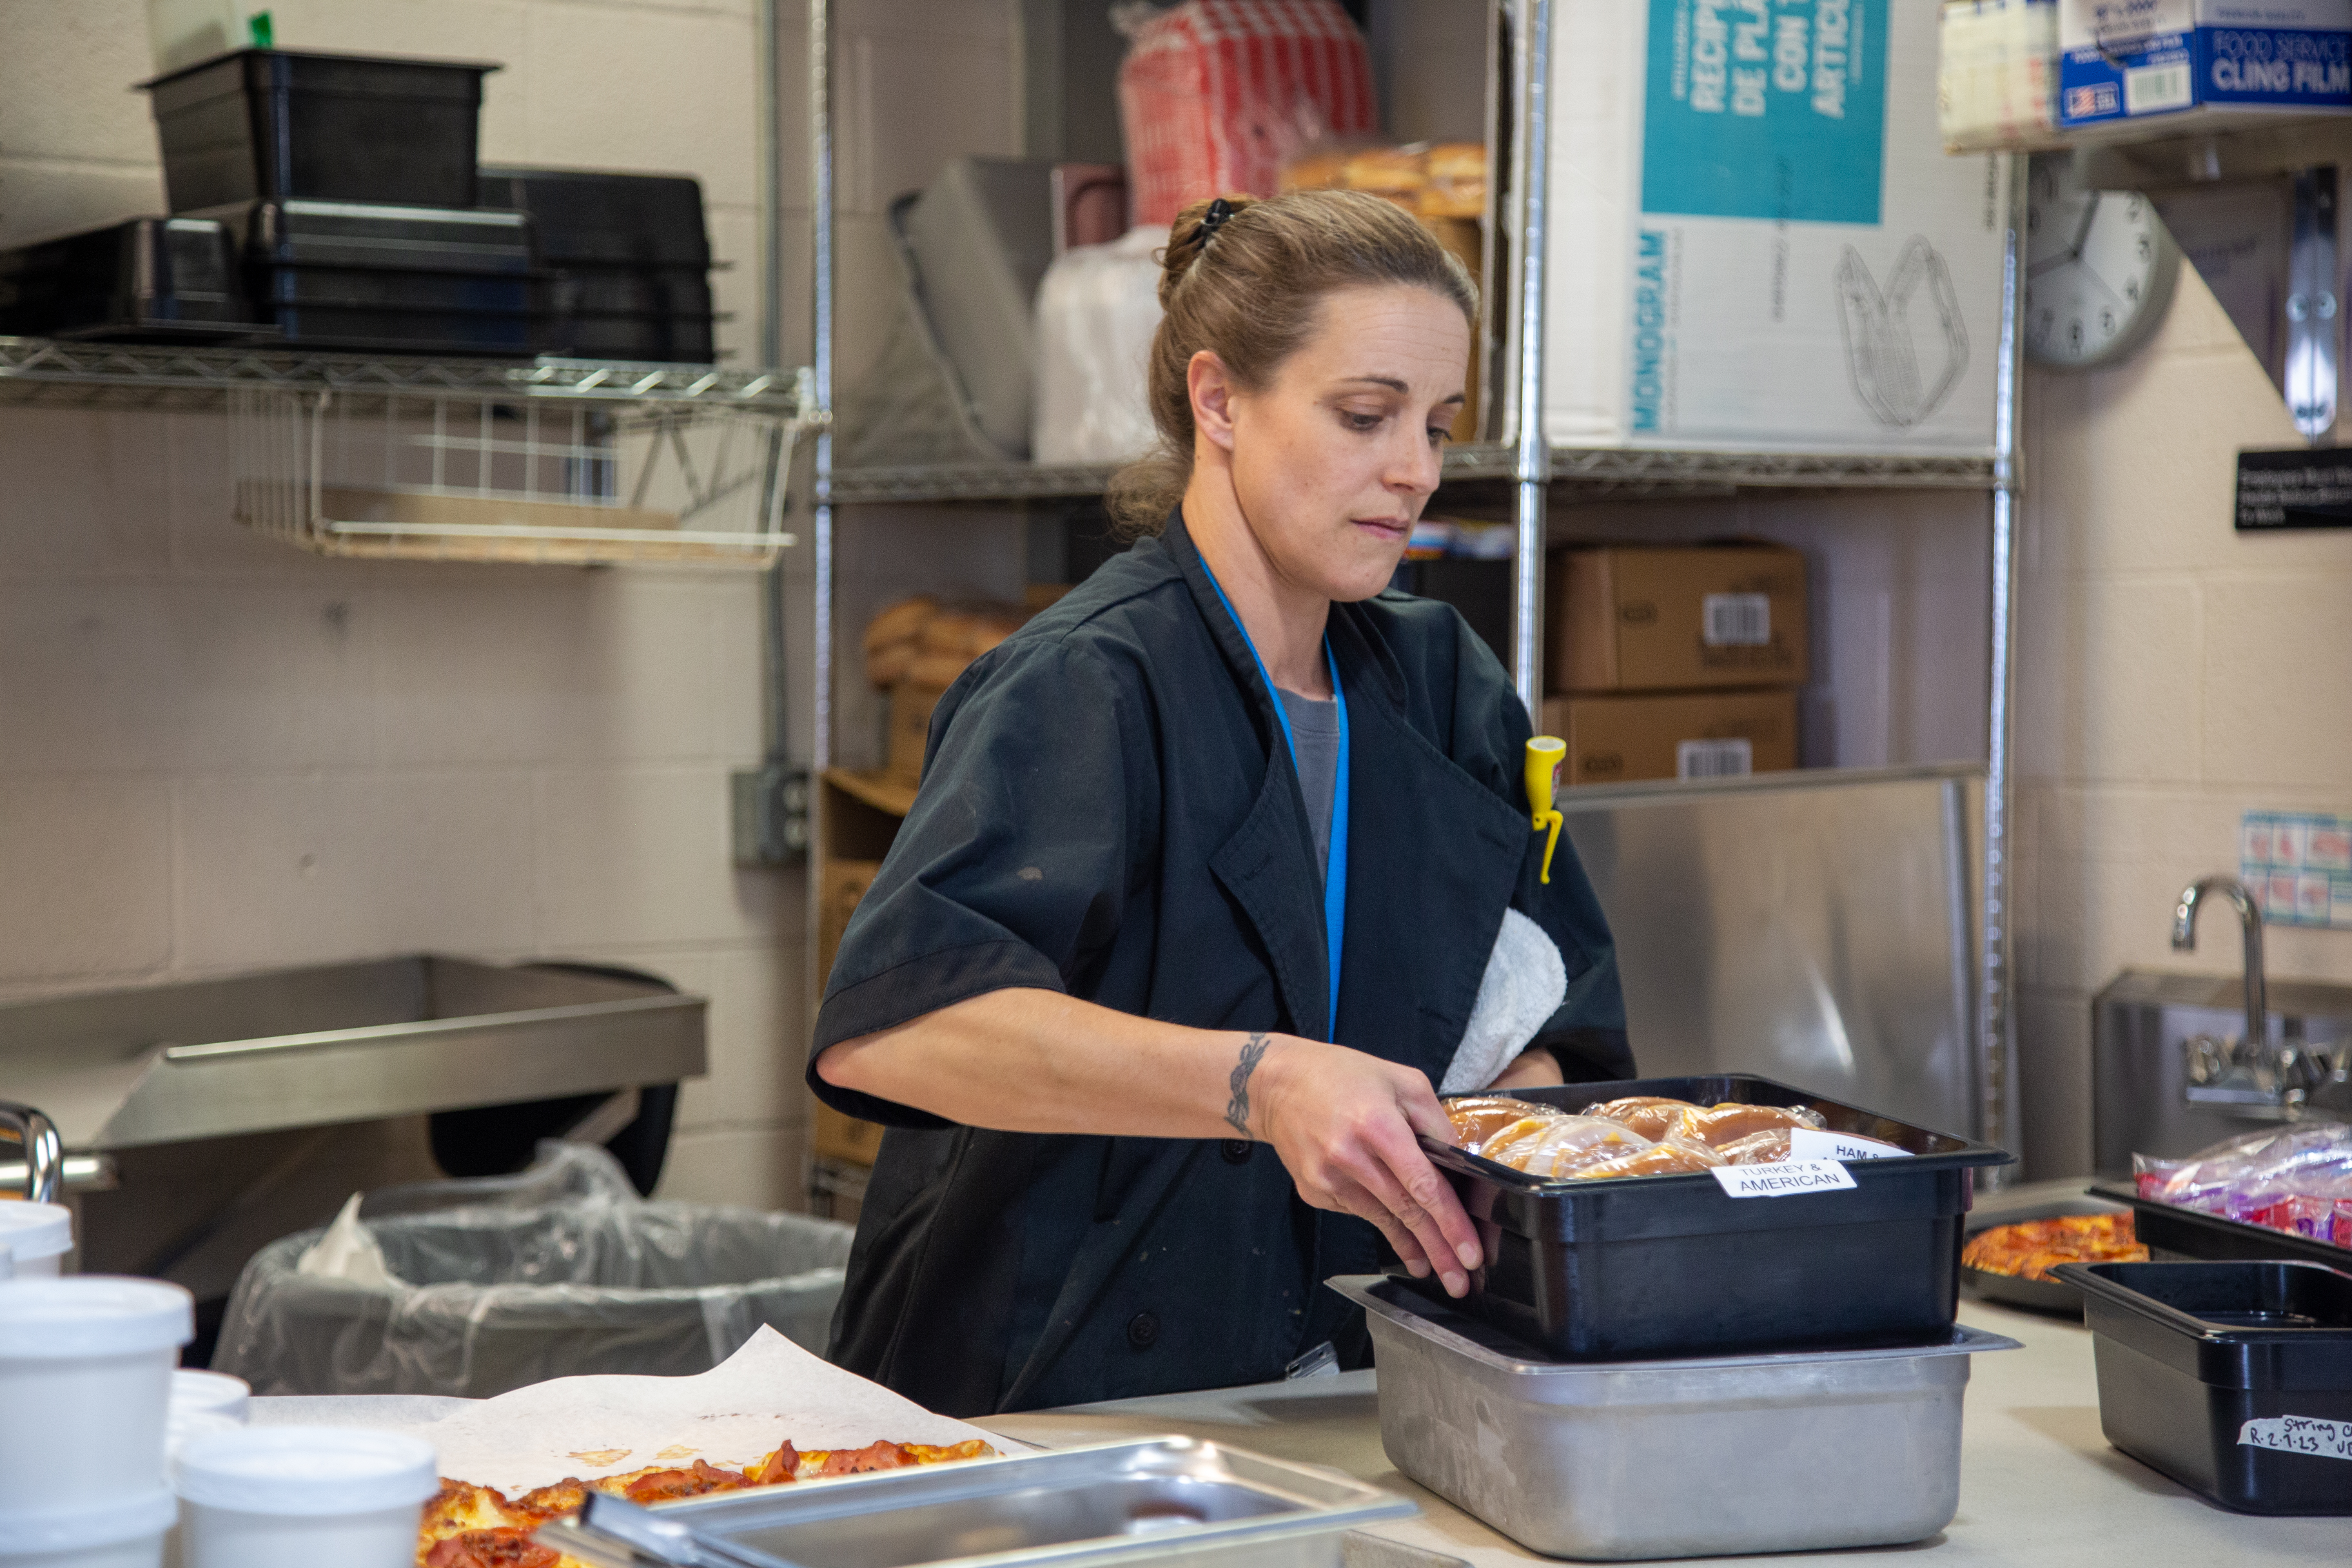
[1030,226,1169,463]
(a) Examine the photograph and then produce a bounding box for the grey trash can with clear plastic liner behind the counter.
[212,1143,851,1399]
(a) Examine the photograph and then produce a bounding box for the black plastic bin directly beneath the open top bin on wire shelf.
[208,202,548,357]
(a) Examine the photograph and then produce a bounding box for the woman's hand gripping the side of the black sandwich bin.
[1228,1034,1479,1295]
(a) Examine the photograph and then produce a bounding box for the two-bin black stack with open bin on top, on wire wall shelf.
[146,49,546,357]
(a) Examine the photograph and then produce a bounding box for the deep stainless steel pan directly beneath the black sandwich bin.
[1329,1274,2018,1561]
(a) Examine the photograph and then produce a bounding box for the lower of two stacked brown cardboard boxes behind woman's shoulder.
[1543,691,1797,785]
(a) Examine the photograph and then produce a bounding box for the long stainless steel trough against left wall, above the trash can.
[0,954,703,1149]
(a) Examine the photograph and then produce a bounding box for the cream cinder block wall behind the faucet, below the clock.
[2018,266,2352,1176]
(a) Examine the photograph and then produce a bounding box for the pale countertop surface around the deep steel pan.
[976,1302,2352,1568]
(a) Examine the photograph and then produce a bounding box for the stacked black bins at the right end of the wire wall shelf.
[480,167,713,364]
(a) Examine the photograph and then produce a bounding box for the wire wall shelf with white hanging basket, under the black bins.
[0,339,823,569]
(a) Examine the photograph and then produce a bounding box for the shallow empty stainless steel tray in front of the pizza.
[539,1437,1418,1568]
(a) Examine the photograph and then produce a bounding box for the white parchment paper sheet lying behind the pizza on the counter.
[256,1328,1018,1495]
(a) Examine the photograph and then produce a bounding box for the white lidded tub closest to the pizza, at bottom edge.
[172,1427,440,1568]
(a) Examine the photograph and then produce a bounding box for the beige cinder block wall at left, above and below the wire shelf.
[0,0,1021,1206]
